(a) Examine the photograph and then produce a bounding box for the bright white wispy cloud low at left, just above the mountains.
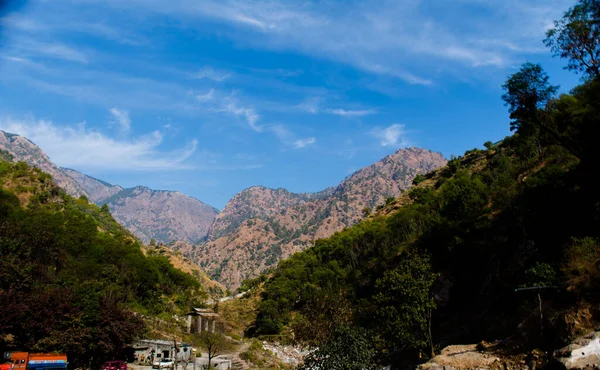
[0,117,198,171]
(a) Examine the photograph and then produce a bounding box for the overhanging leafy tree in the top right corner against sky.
[544,0,600,78]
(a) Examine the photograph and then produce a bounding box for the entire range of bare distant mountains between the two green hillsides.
[0,131,446,289]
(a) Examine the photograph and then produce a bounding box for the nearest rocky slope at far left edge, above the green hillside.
[0,130,89,198]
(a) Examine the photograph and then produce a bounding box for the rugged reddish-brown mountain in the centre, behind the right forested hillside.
[189,148,446,288]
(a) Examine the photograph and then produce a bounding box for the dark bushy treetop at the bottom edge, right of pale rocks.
[299,326,375,370]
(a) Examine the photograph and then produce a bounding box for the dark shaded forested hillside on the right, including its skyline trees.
[250,1,600,369]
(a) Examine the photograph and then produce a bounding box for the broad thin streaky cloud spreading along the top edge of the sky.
[89,0,573,86]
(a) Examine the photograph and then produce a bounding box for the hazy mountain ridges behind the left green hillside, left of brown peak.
[0,131,218,243]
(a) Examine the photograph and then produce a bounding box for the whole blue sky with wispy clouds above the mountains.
[0,0,579,208]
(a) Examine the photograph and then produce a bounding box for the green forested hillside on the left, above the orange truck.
[0,151,206,368]
